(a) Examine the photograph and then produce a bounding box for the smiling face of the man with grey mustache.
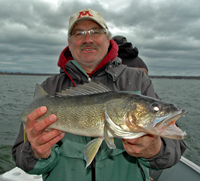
[68,20,110,73]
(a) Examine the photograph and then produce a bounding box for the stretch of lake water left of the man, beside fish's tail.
[0,75,50,174]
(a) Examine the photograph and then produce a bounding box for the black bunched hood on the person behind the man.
[118,43,139,58]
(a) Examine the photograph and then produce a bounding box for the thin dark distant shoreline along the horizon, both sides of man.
[0,72,200,80]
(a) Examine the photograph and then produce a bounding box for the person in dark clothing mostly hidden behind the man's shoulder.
[112,36,148,75]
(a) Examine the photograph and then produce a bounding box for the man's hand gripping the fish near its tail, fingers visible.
[25,107,65,158]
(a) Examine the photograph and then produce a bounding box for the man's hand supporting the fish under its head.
[122,134,162,158]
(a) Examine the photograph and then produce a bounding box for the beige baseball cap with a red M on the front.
[68,8,108,35]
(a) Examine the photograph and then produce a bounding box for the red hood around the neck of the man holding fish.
[57,39,119,74]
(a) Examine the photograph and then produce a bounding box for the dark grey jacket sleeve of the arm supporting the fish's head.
[139,75,186,169]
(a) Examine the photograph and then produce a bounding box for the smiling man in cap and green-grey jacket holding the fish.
[12,9,185,181]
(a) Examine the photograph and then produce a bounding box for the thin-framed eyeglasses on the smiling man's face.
[69,29,106,39]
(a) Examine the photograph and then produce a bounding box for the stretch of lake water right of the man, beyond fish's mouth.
[152,79,200,166]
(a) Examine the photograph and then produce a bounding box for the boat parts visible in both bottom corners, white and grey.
[0,156,200,181]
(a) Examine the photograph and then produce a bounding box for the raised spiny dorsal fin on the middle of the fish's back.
[57,82,110,96]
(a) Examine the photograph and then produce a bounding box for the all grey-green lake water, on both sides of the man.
[0,75,200,174]
